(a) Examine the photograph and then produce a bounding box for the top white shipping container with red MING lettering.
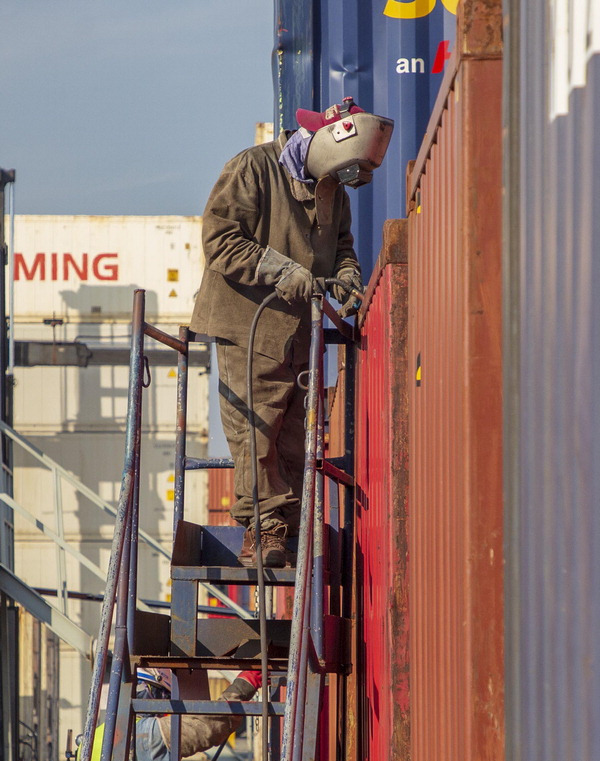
[14,214,203,323]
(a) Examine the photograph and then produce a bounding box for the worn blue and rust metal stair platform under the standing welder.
[81,291,353,761]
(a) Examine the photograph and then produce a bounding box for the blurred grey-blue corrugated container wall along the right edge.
[505,0,600,761]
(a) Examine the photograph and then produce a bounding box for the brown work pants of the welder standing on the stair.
[217,339,308,536]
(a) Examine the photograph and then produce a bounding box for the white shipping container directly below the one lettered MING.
[14,320,208,440]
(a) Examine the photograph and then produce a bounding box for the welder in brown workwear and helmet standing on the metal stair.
[190,98,393,567]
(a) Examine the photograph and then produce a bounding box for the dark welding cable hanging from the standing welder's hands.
[246,277,363,761]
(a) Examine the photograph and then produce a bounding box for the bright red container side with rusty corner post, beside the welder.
[356,220,410,761]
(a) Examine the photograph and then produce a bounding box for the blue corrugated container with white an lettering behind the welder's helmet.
[273,0,457,277]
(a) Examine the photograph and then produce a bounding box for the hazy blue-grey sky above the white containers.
[0,0,274,456]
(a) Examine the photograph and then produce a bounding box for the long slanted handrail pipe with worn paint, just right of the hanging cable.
[281,295,323,761]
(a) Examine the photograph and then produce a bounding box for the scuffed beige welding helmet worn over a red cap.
[296,97,394,188]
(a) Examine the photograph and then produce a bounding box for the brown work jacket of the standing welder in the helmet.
[190,132,360,361]
